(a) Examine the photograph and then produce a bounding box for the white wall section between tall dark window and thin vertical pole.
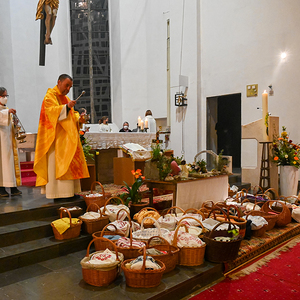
[110,0,169,129]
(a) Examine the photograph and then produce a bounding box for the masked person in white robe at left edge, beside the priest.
[0,87,22,197]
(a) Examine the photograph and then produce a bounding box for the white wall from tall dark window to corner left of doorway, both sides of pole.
[110,0,199,161]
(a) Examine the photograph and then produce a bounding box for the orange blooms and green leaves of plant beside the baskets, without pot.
[120,169,145,206]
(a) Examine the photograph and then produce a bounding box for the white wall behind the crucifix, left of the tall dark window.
[0,0,72,132]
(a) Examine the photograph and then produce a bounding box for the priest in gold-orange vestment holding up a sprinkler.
[34,74,89,199]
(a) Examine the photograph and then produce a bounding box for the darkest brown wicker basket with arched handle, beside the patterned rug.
[203,221,242,263]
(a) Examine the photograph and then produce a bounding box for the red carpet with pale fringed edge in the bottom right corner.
[191,237,300,300]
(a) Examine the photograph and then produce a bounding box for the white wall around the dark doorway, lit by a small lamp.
[201,0,300,169]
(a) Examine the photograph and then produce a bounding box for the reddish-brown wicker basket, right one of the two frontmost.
[121,247,166,288]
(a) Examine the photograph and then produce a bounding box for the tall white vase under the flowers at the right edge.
[280,166,299,197]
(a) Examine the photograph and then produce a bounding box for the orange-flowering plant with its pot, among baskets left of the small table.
[120,169,148,215]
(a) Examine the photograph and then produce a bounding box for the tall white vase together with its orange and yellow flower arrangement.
[272,126,300,197]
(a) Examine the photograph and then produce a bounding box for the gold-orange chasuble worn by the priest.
[34,86,89,186]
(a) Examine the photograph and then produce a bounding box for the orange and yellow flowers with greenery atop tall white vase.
[272,126,300,168]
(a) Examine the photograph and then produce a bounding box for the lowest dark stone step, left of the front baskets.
[0,234,92,273]
